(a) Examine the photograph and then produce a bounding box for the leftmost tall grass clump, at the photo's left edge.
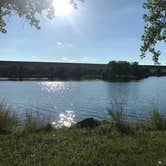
[0,102,18,134]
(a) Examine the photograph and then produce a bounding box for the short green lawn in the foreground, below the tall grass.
[0,125,166,166]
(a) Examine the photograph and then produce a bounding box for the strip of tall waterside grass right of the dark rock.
[108,104,166,133]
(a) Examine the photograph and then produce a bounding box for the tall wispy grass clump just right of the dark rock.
[108,104,131,134]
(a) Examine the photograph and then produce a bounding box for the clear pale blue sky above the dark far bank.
[0,0,166,65]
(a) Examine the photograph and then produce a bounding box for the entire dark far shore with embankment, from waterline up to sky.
[0,61,166,82]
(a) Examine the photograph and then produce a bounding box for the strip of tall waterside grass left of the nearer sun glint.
[0,102,52,134]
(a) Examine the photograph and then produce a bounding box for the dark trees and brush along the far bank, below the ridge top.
[0,61,166,81]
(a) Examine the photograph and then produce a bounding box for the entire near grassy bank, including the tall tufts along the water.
[0,103,166,166]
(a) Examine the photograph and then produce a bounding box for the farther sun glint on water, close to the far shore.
[40,81,66,92]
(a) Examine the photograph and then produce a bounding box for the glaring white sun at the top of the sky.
[53,0,73,17]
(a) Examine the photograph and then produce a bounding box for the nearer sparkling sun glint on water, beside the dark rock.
[52,110,75,128]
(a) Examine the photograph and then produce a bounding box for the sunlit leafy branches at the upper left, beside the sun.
[0,0,77,33]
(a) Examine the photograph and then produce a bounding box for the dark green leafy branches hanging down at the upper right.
[140,0,166,64]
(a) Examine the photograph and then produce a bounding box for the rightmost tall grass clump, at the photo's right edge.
[149,106,166,130]
